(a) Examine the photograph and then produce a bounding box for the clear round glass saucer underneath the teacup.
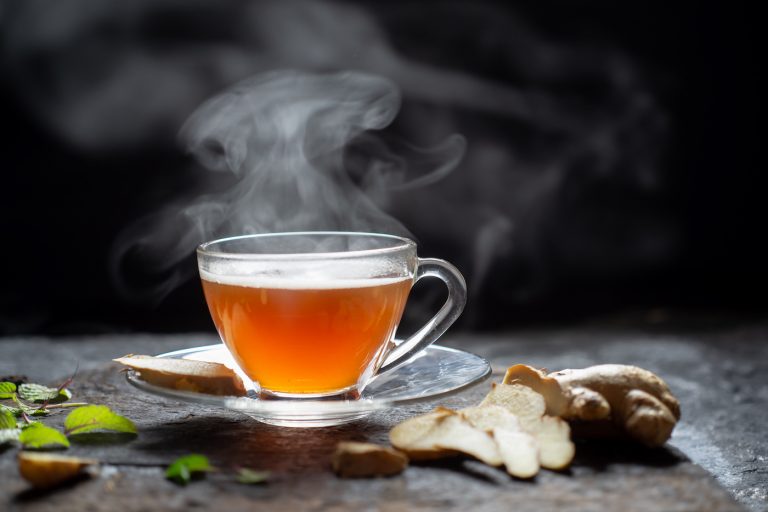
[126,344,491,427]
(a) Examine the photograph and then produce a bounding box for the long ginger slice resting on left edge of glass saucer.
[113,354,246,396]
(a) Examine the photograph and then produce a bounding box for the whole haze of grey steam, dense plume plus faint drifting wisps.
[0,0,668,316]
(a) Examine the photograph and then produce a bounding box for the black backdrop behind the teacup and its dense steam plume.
[0,1,768,335]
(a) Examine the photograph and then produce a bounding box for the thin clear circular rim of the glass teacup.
[197,231,416,261]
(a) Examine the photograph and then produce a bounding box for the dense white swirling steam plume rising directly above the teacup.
[114,71,465,298]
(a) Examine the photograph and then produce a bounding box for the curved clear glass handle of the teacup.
[377,258,467,375]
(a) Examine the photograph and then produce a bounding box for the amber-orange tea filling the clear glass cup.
[202,276,411,393]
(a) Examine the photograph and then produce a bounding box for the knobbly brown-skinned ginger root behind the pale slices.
[503,364,680,447]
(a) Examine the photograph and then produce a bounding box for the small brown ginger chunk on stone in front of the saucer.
[331,441,408,478]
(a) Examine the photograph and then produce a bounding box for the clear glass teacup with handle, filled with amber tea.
[197,232,466,400]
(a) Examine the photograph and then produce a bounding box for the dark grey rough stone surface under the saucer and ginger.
[0,324,768,511]
